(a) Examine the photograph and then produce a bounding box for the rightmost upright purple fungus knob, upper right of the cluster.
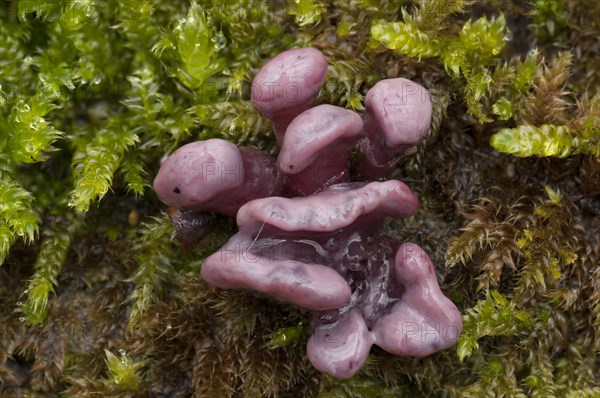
[358,78,432,180]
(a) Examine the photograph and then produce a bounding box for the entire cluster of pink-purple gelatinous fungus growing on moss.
[154,48,462,378]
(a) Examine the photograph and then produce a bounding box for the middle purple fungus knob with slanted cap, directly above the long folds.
[277,105,363,196]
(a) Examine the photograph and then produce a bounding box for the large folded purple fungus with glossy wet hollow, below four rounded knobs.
[201,180,462,377]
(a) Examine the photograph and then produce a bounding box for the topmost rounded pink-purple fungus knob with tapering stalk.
[251,47,327,145]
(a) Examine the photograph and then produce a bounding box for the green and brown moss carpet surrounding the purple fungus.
[0,0,600,397]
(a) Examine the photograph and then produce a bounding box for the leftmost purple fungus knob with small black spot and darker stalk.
[153,139,284,215]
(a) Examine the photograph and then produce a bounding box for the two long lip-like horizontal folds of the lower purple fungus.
[201,181,418,311]
